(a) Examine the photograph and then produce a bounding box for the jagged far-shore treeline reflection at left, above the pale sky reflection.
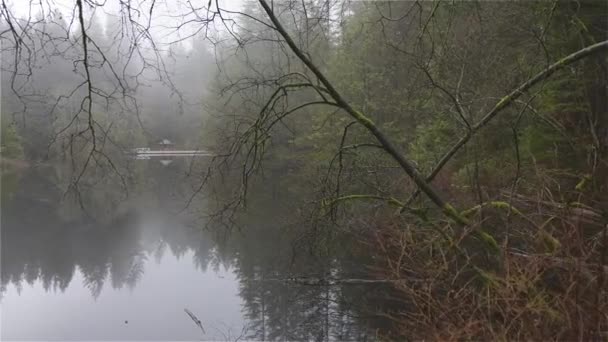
[1,165,218,296]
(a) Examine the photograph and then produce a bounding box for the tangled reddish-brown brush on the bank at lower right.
[372,180,608,341]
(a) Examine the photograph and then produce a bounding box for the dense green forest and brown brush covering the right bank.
[207,1,608,339]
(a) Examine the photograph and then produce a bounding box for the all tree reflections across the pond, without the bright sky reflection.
[1,166,390,341]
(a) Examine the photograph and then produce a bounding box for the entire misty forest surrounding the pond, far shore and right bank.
[0,0,608,340]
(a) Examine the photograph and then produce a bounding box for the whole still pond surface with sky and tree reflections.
[0,160,379,341]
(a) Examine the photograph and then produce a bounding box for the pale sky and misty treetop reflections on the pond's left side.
[1,164,246,340]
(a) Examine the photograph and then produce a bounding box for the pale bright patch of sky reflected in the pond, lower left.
[2,252,244,341]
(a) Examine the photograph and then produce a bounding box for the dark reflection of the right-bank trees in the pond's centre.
[219,182,381,341]
